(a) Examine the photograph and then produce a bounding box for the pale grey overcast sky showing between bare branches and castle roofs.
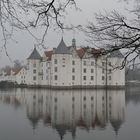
[0,0,131,67]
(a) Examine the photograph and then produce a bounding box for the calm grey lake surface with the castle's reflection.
[0,88,140,140]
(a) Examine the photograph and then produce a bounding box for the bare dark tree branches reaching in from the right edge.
[84,5,140,68]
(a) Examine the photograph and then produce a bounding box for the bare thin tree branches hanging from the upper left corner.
[0,0,76,52]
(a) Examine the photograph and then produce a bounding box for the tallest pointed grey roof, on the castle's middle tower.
[54,38,70,54]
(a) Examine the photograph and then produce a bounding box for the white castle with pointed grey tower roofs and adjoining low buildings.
[0,38,125,88]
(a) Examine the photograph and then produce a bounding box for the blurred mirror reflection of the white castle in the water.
[0,89,125,139]
